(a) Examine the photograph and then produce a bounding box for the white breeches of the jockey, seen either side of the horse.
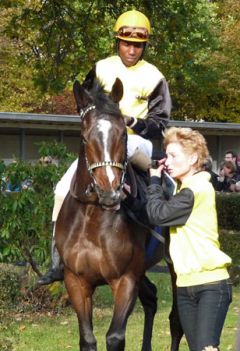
[52,134,153,222]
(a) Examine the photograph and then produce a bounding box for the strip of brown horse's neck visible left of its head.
[70,142,97,203]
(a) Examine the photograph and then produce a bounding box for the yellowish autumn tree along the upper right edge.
[203,0,240,123]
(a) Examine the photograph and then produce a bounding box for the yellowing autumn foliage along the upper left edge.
[0,3,42,112]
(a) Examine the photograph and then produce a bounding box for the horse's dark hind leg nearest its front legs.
[138,276,157,351]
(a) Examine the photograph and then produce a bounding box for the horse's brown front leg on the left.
[64,269,97,351]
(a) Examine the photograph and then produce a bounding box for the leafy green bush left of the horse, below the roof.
[0,143,72,274]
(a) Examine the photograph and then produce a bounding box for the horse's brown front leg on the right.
[107,276,138,351]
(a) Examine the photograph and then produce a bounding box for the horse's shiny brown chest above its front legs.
[63,209,144,280]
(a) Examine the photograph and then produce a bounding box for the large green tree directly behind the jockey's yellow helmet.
[1,0,239,120]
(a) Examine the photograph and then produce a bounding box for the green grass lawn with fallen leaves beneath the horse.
[0,273,240,351]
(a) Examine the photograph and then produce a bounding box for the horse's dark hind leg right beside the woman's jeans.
[168,264,184,351]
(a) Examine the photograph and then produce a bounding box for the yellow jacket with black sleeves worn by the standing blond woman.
[147,172,231,287]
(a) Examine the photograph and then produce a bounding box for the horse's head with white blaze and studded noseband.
[73,79,127,209]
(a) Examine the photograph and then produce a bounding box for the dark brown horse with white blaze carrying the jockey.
[55,78,182,351]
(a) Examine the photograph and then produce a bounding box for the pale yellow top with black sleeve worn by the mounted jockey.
[96,56,171,138]
